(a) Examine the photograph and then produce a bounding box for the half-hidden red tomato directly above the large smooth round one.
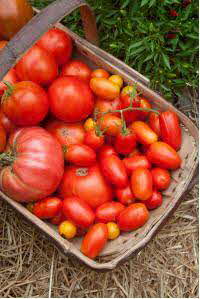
[61,60,92,83]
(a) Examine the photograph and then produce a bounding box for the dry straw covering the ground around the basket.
[0,88,198,298]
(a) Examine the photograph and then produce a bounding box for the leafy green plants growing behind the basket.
[32,0,198,99]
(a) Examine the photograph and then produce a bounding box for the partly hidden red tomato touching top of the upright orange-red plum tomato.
[123,155,151,175]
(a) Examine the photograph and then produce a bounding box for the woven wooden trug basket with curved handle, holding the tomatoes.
[0,0,198,270]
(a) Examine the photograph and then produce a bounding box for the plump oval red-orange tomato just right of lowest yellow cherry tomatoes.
[118,203,149,231]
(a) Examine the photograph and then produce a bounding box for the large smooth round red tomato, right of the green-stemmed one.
[49,76,94,122]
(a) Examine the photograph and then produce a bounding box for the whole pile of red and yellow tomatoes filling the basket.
[0,28,181,259]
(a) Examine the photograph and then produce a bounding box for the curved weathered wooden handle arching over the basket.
[0,0,98,80]
